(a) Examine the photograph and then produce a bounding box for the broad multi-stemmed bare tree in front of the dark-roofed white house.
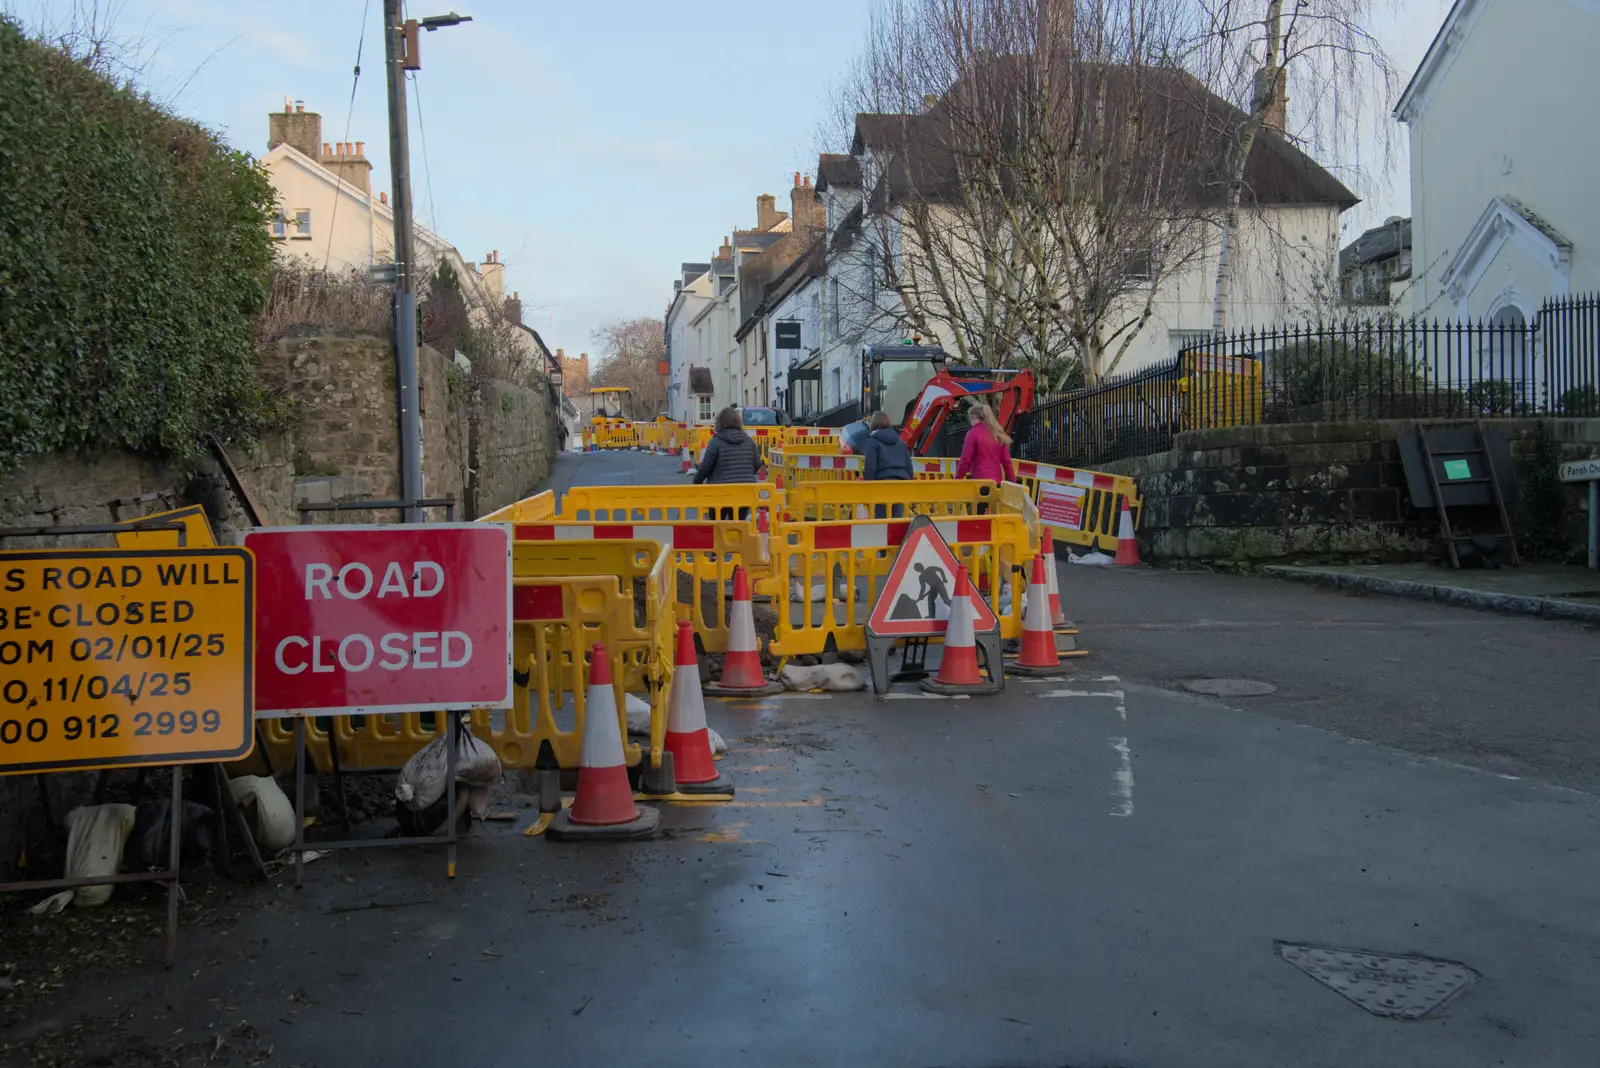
[854,0,1218,385]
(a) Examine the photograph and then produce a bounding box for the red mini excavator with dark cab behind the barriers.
[845,344,1034,456]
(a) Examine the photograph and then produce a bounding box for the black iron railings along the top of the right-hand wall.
[1018,296,1600,467]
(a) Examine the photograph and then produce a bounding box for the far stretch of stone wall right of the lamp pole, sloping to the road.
[467,379,557,516]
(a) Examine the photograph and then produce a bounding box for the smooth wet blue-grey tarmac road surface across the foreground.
[12,457,1600,1068]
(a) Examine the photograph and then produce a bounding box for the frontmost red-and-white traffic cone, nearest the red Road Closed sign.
[546,643,661,841]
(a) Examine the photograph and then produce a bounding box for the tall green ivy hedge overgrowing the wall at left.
[0,18,274,472]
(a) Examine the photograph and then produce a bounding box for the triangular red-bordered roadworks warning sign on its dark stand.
[866,515,1000,695]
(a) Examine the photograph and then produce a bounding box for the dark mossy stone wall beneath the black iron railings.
[1104,419,1600,568]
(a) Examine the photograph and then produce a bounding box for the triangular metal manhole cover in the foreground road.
[1274,942,1478,1020]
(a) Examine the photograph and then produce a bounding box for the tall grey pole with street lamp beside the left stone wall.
[384,0,472,523]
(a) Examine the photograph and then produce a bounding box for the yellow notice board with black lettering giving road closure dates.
[0,548,256,775]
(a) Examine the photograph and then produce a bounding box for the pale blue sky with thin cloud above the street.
[0,0,1448,353]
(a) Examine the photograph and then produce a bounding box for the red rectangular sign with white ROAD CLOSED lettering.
[245,523,510,719]
